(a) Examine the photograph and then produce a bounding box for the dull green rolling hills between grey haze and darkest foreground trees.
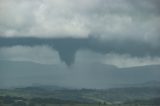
[0,81,160,103]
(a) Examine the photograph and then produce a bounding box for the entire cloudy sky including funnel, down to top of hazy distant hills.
[0,0,160,88]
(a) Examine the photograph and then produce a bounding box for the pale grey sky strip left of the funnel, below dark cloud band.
[0,46,61,64]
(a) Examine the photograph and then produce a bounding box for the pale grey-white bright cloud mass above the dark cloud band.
[0,0,160,43]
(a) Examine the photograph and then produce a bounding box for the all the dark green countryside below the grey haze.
[0,87,160,106]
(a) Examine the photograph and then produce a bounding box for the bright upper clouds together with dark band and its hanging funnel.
[0,0,160,65]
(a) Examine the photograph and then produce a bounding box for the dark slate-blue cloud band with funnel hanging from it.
[0,37,160,65]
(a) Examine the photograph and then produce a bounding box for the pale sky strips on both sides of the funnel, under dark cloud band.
[0,46,160,68]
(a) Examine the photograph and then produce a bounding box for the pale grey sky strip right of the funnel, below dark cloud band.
[74,50,160,68]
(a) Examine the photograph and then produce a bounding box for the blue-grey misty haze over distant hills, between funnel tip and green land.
[0,61,160,89]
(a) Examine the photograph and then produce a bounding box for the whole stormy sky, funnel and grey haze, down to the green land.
[0,0,160,88]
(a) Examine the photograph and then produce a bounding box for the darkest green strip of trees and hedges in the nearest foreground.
[0,96,160,106]
